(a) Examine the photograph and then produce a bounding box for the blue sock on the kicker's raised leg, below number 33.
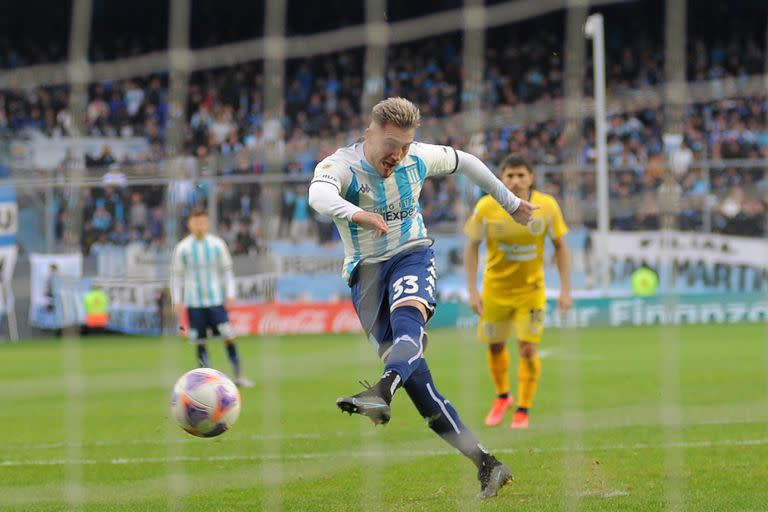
[384,306,424,385]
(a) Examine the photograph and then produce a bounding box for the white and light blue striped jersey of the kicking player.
[312,142,459,281]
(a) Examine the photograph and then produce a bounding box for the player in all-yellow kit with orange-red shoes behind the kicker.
[464,155,572,428]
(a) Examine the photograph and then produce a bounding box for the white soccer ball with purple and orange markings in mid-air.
[171,368,240,437]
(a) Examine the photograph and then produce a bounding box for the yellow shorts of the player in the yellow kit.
[477,288,547,343]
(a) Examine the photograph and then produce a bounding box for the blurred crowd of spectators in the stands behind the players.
[0,5,768,252]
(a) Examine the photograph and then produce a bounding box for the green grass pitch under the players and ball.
[0,325,768,512]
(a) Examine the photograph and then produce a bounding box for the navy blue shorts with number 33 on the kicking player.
[350,247,437,355]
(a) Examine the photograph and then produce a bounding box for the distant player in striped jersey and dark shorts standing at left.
[171,210,253,387]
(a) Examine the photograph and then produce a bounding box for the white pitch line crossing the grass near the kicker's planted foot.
[0,438,768,468]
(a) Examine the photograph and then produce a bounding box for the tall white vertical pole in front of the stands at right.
[584,14,611,295]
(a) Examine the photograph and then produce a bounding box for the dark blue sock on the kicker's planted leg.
[403,358,489,468]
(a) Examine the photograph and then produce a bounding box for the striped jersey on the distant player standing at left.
[171,234,235,308]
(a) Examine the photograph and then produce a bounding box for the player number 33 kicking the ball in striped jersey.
[309,98,538,498]
